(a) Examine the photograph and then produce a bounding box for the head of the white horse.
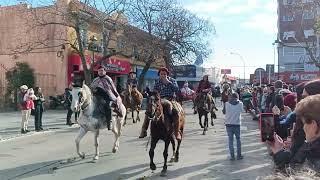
[71,85,91,112]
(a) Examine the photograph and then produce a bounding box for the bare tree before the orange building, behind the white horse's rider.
[11,0,126,84]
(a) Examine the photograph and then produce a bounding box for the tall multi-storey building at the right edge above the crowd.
[276,0,320,84]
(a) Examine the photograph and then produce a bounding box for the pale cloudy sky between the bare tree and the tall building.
[181,0,277,78]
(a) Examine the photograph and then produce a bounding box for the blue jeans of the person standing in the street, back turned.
[226,124,241,158]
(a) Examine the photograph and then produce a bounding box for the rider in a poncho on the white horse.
[91,65,124,130]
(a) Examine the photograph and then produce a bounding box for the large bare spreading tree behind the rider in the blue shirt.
[127,0,214,90]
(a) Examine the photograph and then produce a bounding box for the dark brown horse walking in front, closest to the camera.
[145,92,185,176]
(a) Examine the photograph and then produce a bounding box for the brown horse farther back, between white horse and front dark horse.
[122,85,143,124]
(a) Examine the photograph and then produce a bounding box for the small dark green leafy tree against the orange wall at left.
[6,62,35,107]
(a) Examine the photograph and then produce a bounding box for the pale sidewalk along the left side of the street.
[0,110,74,142]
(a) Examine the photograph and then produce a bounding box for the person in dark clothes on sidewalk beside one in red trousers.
[34,87,45,132]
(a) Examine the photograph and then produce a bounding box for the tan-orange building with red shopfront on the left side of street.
[0,0,164,105]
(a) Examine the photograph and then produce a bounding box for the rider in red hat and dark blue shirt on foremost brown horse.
[139,67,181,140]
